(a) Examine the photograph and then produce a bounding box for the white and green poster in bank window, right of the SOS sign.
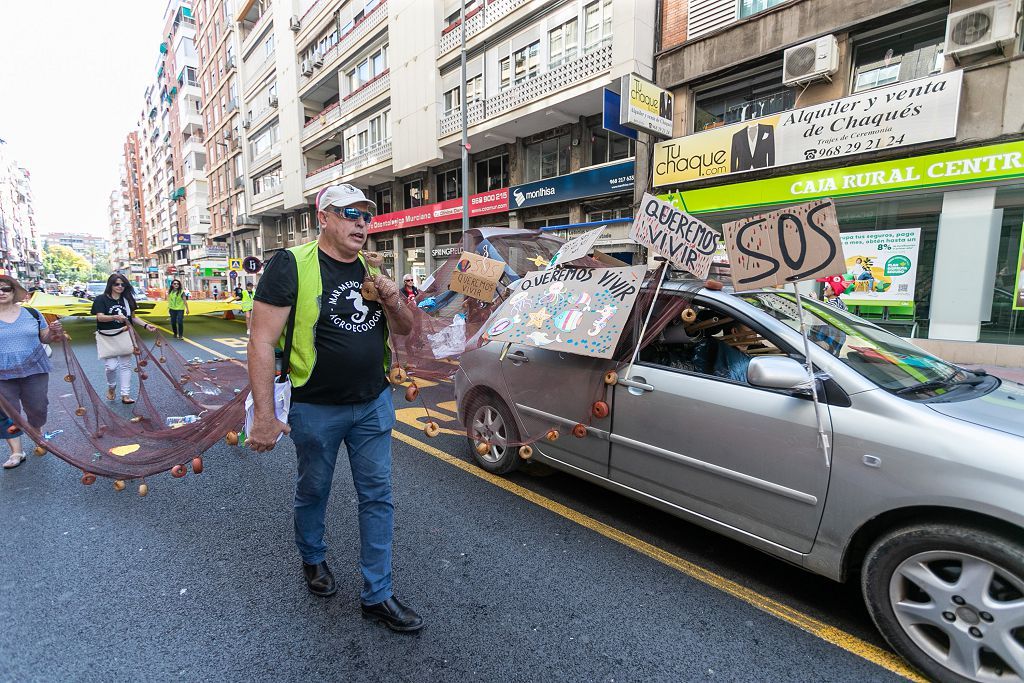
[828,227,921,306]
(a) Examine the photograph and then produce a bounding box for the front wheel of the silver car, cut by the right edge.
[861,524,1024,683]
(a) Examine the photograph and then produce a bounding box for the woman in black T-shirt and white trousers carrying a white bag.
[91,273,157,403]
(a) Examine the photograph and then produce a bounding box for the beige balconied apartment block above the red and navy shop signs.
[237,0,656,279]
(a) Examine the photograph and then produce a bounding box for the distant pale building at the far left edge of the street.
[0,140,42,284]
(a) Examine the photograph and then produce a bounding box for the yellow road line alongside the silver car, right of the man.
[391,430,927,683]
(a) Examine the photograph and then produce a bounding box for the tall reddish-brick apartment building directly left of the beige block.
[190,0,261,291]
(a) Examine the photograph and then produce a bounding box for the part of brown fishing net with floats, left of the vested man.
[0,329,248,493]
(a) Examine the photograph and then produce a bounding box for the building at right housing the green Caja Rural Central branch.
[655,0,1024,366]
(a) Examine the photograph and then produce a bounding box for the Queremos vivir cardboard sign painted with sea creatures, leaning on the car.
[485,265,647,358]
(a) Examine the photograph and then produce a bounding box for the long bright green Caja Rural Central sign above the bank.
[659,140,1024,213]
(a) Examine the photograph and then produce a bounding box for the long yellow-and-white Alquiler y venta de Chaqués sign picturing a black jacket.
[653,70,964,186]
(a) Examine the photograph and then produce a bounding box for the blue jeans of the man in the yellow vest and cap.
[288,386,394,605]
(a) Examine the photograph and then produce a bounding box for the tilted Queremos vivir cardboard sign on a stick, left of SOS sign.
[630,194,719,280]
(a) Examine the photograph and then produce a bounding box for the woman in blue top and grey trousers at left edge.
[0,275,65,470]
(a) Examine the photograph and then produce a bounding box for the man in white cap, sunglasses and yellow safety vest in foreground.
[247,184,423,632]
